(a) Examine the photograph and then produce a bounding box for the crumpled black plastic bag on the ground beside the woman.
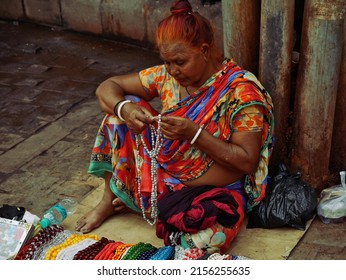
[247,164,317,230]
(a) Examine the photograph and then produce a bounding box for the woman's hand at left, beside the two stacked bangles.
[120,102,154,134]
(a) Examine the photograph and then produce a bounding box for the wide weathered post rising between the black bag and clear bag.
[291,0,345,189]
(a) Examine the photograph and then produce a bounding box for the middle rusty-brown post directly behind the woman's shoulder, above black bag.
[258,0,294,170]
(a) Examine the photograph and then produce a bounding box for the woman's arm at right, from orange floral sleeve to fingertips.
[161,107,262,175]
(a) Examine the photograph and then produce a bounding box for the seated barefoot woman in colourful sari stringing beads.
[76,0,273,254]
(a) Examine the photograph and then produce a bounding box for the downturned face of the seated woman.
[160,43,210,87]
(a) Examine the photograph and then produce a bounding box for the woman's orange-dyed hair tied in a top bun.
[156,0,216,56]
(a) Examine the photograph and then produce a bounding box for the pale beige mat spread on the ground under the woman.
[62,184,312,260]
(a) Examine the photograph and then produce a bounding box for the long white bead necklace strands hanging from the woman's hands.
[136,114,163,226]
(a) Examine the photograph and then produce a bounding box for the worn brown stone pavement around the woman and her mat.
[0,22,346,259]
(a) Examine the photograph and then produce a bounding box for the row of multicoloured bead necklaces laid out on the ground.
[15,225,249,260]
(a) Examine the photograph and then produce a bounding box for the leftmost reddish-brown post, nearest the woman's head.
[222,0,261,75]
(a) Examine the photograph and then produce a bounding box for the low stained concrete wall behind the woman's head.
[0,0,223,49]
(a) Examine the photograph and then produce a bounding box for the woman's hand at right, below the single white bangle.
[161,116,199,141]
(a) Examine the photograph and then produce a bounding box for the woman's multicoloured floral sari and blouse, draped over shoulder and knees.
[89,61,274,252]
